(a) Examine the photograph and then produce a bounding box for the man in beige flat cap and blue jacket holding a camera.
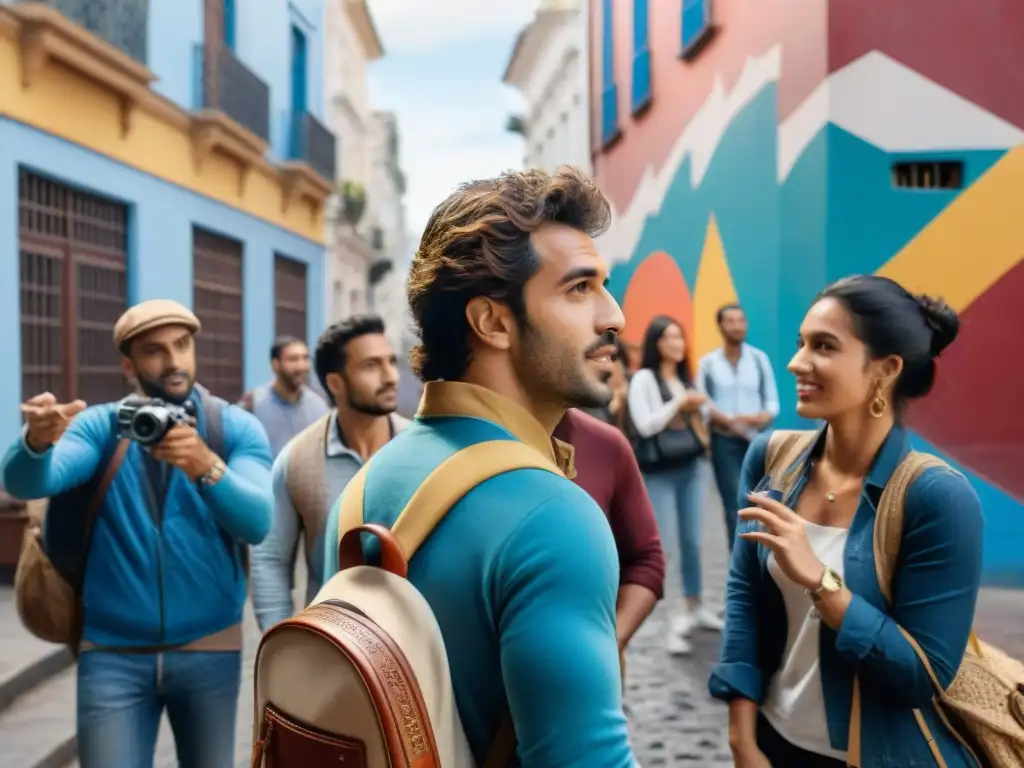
[3,299,273,768]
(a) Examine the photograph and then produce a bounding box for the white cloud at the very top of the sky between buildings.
[370,0,537,54]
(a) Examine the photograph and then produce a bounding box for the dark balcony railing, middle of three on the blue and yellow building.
[195,43,270,141]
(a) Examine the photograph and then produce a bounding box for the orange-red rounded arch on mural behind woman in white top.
[623,251,694,372]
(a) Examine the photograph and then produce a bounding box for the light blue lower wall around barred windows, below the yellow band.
[0,118,325,442]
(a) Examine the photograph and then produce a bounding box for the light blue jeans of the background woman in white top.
[643,459,701,597]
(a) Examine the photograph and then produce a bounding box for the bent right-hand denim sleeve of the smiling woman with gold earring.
[836,467,982,708]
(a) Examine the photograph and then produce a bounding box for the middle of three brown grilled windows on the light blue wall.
[193,226,245,402]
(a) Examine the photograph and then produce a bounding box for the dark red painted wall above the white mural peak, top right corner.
[828,0,1024,126]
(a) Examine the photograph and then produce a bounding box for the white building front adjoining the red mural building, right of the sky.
[503,0,591,173]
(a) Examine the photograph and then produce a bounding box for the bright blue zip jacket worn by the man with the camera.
[2,395,273,647]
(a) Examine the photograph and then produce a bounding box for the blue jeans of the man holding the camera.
[78,650,242,768]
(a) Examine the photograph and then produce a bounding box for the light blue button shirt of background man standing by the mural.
[694,344,778,419]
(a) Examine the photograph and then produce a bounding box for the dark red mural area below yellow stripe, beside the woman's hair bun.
[907,262,1024,500]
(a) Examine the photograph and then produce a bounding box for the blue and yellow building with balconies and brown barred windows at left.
[0,0,335,434]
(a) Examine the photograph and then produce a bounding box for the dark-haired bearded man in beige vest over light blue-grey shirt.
[252,314,409,631]
